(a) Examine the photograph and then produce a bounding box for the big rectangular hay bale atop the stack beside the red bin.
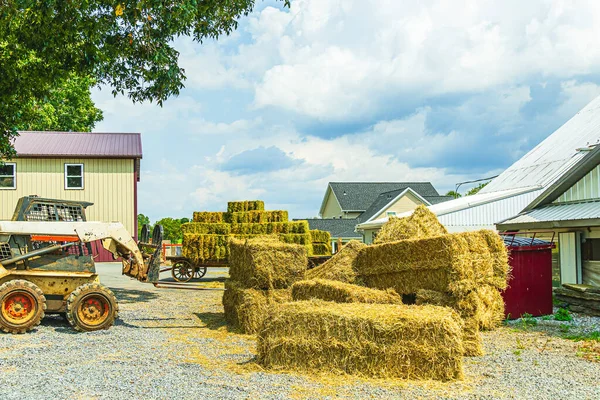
[356,231,506,294]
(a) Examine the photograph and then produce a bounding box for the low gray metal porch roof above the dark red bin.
[504,201,600,225]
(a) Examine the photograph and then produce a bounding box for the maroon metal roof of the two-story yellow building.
[14,131,142,158]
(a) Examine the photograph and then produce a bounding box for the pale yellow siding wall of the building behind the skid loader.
[0,158,135,235]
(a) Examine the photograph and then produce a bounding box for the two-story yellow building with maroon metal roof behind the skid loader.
[0,131,142,261]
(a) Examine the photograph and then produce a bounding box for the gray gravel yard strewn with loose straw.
[0,265,600,400]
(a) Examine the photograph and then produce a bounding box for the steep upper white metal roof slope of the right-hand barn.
[481,97,600,193]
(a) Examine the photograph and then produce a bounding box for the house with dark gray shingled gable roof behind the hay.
[308,182,452,247]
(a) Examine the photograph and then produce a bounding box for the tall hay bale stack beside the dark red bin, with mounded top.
[355,209,509,356]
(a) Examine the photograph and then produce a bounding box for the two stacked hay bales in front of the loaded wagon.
[223,236,308,334]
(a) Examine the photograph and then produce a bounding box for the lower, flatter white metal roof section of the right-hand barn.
[438,190,541,231]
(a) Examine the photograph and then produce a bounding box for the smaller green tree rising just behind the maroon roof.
[17,75,103,132]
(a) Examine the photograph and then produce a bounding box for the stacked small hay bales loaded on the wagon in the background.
[182,200,322,262]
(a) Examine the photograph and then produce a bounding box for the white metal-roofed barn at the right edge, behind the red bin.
[357,97,600,286]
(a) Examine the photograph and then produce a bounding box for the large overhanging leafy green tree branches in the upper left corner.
[0,0,290,158]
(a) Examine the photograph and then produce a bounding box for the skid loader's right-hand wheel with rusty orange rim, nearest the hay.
[66,282,119,332]
